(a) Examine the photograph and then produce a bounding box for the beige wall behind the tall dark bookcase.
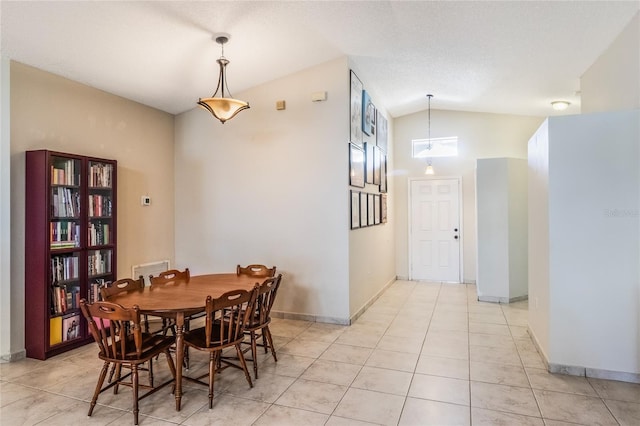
[10,62,174,356]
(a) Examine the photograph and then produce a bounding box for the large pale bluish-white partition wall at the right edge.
[529,110,640,381]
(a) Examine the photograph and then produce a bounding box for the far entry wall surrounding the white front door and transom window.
[393,110,543,282]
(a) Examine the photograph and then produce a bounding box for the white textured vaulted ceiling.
[0,0,640,116]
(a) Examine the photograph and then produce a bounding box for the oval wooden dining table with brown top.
[108,273,262,411]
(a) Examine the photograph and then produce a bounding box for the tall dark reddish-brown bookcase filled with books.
[25,150,117,359]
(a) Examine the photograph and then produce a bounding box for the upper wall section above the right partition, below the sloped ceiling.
[580,12,640,114]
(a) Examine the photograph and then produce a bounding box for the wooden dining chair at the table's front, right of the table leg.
[184,286,258,409]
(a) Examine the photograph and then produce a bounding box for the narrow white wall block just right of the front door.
[476,158,527,303]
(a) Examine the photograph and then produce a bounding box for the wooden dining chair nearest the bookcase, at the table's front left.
[80,299,176,425]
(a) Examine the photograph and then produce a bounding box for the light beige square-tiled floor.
[0,281,640,426]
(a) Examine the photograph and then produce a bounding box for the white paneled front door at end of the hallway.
[409,178,461,282]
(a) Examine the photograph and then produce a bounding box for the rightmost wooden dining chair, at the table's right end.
[244,274,282,379]
